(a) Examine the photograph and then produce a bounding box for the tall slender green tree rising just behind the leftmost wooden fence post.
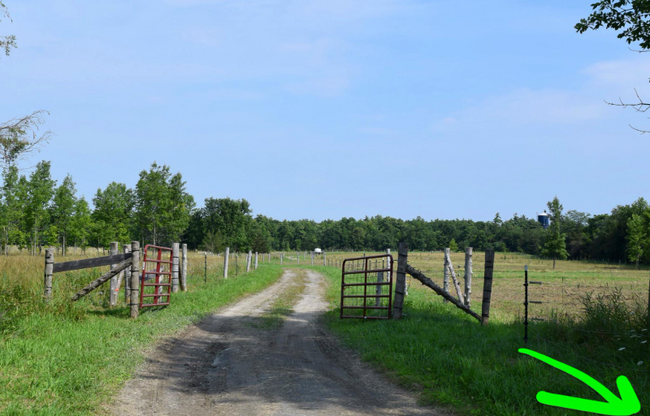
[25,161,56,254]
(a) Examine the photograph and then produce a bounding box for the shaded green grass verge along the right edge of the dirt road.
[317,267,650,416]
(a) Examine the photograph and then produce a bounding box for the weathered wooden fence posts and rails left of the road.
[43,241,187,318]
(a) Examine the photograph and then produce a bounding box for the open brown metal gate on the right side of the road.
[341,254,393,319]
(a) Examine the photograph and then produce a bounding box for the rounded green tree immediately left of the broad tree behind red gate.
[92,182,134,247]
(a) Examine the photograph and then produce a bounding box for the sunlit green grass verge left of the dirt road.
[0,265,282,415]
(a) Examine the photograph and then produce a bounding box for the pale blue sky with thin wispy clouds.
[0,0,650,221]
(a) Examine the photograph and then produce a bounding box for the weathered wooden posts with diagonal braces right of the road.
[393,243,494,325]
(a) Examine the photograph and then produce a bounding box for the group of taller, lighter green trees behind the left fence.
[0,161,195,254]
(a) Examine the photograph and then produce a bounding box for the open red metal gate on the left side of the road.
[140,244,172,308]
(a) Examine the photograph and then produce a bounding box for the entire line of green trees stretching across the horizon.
[0,161,650,264]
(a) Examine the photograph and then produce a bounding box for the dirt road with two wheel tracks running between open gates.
[111,270,443,416]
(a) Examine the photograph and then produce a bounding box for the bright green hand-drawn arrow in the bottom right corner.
[519,348,641,416]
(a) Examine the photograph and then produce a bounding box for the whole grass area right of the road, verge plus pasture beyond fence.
[290,253,650,416]
